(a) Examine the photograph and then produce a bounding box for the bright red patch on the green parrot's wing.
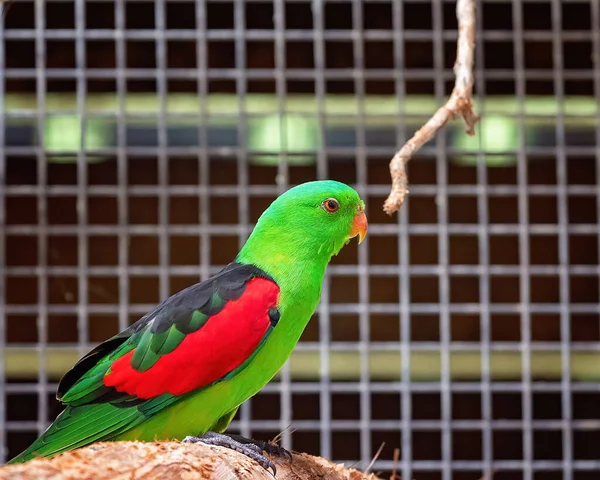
[104,278,279,400]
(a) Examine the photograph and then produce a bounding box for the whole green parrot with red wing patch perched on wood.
[8,180,368,473]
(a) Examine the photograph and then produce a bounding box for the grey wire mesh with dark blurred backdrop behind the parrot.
[0,0,600,480]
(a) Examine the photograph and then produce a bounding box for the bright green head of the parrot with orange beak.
[237,180,367,283]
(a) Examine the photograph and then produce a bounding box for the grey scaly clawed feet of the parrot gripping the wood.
[183,432,292,475]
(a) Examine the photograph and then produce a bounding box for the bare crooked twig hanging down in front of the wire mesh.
[383,0,479,215]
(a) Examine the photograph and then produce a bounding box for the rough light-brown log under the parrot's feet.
[0,442,381,480]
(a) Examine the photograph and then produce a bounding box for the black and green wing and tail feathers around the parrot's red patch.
[9,263,276,463]
